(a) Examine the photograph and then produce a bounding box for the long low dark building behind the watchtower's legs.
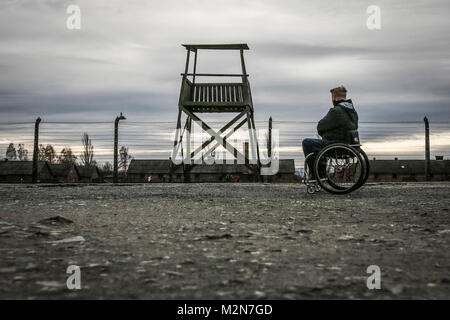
[127,159,295,183]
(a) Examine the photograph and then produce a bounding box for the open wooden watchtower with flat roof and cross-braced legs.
[172,44,260,174]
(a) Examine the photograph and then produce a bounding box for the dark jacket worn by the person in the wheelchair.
[317,99,358,142]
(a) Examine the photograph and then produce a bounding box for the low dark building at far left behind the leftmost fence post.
[0,161,54,183]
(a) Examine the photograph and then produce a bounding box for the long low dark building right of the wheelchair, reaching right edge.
[368,160,450,182]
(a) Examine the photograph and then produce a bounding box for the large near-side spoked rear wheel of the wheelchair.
[314,143,368,194]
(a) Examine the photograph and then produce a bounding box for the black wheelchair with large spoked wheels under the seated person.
[303,130,370,194]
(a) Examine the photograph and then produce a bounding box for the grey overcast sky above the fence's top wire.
[0,0,450,164]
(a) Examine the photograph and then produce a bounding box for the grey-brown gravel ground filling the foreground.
[0,183,450,299]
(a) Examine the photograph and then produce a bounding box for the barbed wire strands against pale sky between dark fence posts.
[0,119,450,168]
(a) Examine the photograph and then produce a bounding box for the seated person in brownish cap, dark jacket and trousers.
[302,86,358,179]
